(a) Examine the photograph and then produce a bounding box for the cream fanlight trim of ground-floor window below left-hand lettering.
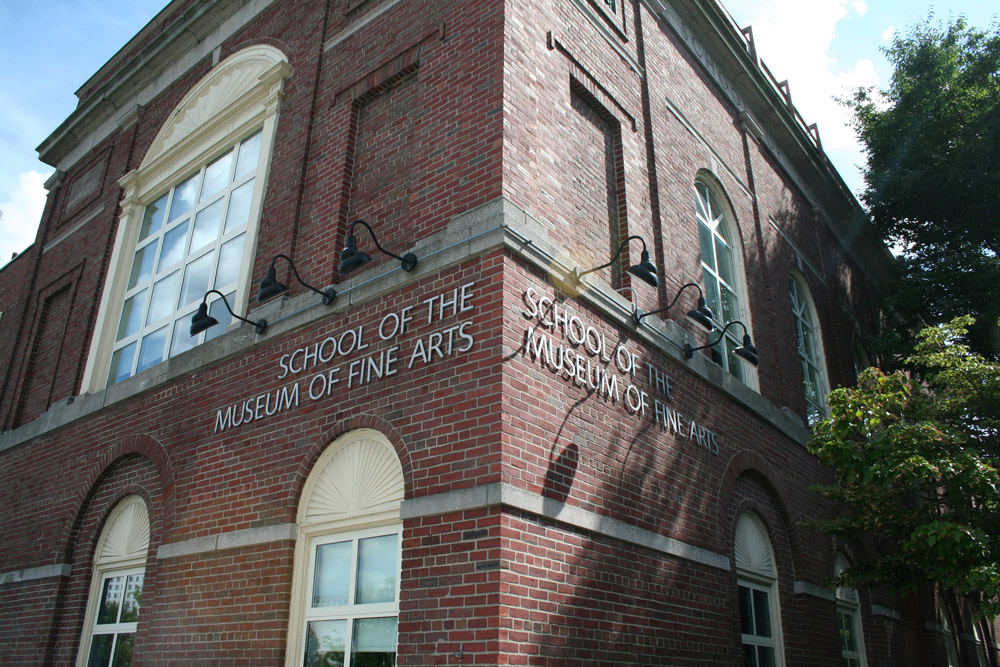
[285,429,403,667]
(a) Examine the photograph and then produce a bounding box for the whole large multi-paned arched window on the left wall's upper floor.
[83,45,292,391]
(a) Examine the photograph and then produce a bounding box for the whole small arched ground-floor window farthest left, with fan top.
[76,496,149,667]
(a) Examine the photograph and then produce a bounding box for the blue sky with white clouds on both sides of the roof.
[0,0,1000,266]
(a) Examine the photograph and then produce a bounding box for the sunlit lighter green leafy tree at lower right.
[809,316,1000,616]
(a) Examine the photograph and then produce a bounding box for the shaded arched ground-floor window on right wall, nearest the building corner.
[734,512,784,667]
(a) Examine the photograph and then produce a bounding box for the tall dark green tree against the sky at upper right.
[847,17,1000,355]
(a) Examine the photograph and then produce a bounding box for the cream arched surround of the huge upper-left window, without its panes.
[82,45,292,392]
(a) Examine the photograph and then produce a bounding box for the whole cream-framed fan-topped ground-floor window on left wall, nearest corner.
[286,429,403,667]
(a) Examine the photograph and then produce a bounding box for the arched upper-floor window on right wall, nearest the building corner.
[694,179,757,388]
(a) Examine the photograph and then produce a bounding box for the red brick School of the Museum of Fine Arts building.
[0,0,995,666]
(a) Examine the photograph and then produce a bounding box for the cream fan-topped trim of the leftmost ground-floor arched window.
[76,495,149,667]
